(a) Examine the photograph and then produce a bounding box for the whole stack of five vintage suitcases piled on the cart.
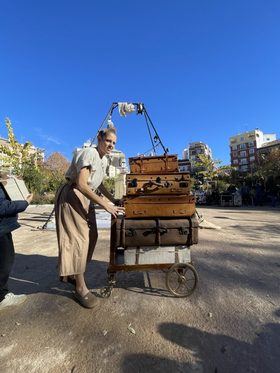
[112,155,198,265]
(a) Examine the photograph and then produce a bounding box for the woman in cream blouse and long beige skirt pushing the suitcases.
[55,128,124,308]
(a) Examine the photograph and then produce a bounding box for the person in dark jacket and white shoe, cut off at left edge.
[0,177,33,310]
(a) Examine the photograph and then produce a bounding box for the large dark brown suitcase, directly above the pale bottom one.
[111,215,198,248]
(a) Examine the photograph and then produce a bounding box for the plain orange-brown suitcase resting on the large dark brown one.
[124,195,195,218]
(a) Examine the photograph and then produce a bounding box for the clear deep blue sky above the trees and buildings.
[0,0,280,164]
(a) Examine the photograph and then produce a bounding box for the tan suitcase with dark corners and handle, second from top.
[126,172,191,195]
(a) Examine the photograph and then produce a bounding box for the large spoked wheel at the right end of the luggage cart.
[166,263,198,298]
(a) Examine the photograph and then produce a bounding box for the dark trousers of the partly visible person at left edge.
[0,233,15,302]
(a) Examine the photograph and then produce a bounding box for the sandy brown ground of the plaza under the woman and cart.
[0,206,280,373]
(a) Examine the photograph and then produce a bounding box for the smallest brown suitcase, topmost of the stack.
[129,154,179,174]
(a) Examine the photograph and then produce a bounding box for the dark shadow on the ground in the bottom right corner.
[122,323,280,373]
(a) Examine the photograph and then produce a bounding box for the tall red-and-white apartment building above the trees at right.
[230,128,276,172]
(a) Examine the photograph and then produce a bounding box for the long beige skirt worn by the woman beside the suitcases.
[55,184,98,276]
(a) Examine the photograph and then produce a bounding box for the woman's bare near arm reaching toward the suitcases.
[76,167,124,217]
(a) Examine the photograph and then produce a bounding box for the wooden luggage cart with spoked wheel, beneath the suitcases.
[101,218,198,298]
